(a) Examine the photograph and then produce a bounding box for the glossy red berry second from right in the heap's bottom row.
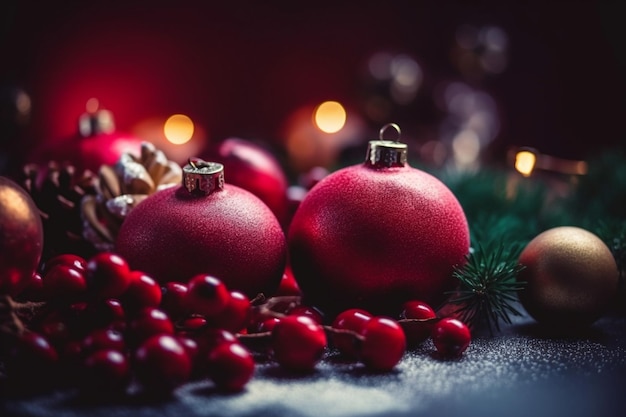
[134,334,191,392]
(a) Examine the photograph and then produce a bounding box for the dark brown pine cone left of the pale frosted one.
[21,161,97,262]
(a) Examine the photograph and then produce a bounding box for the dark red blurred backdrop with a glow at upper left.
[0,0,626,169]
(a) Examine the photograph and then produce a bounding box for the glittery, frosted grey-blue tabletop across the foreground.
[0,317,626,417]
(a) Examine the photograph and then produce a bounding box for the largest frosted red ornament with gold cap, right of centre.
[288,125,469,315]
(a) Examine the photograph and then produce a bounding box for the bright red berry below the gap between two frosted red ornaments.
[272,316,327,372]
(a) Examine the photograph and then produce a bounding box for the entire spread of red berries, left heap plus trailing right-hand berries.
[0,252,470,395]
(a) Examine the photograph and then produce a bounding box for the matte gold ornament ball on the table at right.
[518,226,619,329]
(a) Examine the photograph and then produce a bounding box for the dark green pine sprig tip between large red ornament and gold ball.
[449,243,524,333]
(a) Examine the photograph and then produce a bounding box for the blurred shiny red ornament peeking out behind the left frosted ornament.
[209,138,289,224]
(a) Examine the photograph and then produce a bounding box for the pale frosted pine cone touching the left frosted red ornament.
[81,142,182,251]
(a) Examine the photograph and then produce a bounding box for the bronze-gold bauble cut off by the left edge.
[0,177,43,295]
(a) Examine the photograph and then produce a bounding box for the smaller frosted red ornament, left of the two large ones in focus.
[116,160,287,298]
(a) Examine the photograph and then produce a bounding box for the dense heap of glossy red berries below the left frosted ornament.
[0,252,254,394]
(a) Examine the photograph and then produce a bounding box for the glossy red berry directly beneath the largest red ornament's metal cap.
[360,317,406,372]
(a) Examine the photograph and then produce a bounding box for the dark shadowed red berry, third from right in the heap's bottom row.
[80,349,130,396]
